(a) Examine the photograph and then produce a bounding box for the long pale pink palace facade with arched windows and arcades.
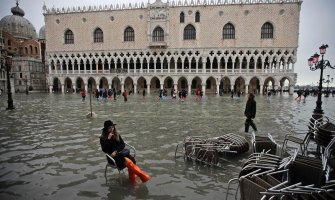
[44,0,302,94]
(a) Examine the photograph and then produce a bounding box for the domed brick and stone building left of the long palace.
[0,0,46,94]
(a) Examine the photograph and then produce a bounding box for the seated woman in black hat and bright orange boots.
[100,120,151,182]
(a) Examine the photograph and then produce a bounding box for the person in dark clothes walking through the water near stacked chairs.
[244,93,257,133]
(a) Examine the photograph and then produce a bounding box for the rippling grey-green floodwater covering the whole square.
[0,93,335,200]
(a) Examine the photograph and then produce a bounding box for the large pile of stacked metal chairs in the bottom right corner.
[226,116,335,200]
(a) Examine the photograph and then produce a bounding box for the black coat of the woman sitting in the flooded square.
[100,135,125,169]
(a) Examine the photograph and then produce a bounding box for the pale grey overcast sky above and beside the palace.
[0,0,335,86]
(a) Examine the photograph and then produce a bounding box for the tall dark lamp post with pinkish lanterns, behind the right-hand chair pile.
[308,44,335,115]
